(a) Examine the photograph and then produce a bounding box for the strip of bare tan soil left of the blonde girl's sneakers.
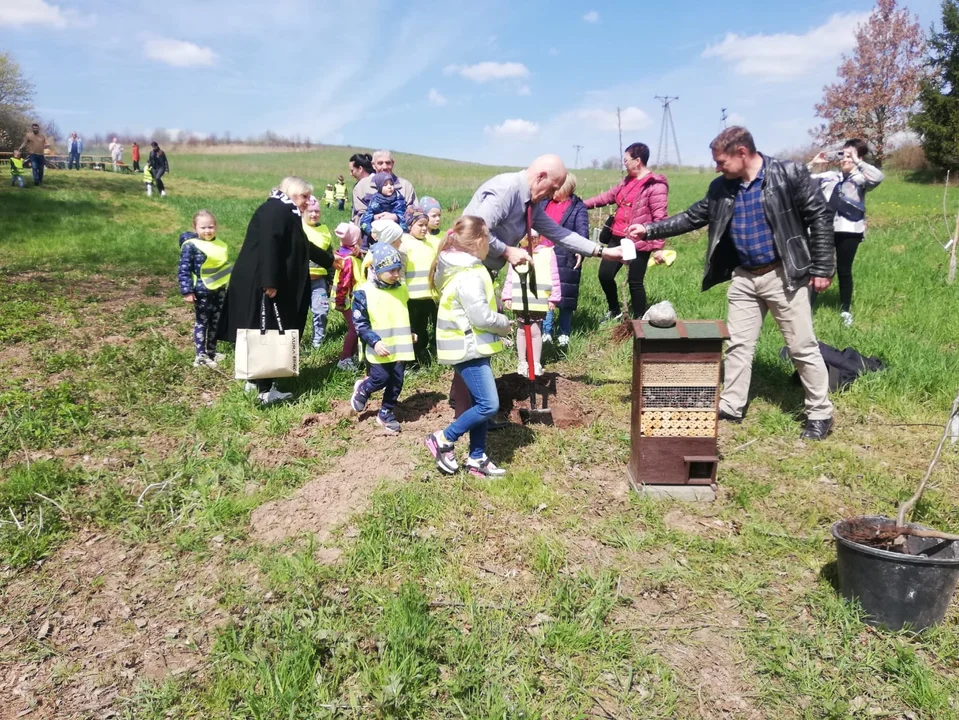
[250,426,414,542]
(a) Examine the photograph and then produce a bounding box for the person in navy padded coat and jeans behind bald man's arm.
[542,173,589,347]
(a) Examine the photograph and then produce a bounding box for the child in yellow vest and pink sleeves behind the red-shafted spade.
[503,230,561,377]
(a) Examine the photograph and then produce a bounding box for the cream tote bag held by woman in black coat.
[235,294,300,380]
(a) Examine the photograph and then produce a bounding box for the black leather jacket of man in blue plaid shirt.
[646,157,836,290]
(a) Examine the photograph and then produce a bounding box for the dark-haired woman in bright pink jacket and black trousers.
[586,143,669,321]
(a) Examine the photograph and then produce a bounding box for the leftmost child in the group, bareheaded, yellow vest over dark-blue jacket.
[177,210,233,368]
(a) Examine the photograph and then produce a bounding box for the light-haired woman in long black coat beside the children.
[219,177,333,404]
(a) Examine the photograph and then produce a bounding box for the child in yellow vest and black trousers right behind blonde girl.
[402,205,437,365]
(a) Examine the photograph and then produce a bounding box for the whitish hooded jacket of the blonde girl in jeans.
[433,250,510,365]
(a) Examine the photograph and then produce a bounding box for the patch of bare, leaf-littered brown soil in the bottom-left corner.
[0,535,244,718]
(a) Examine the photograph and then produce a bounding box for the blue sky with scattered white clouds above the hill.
[0,0,939,170]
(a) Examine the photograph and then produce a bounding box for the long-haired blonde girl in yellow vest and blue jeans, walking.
[425,215,511,477]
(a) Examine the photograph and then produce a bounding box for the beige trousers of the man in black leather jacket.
[719,266,832,420]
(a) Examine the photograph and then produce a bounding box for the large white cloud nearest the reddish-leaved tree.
[702,12,869,82]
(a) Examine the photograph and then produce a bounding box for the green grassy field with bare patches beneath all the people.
[0,149,959,720]
